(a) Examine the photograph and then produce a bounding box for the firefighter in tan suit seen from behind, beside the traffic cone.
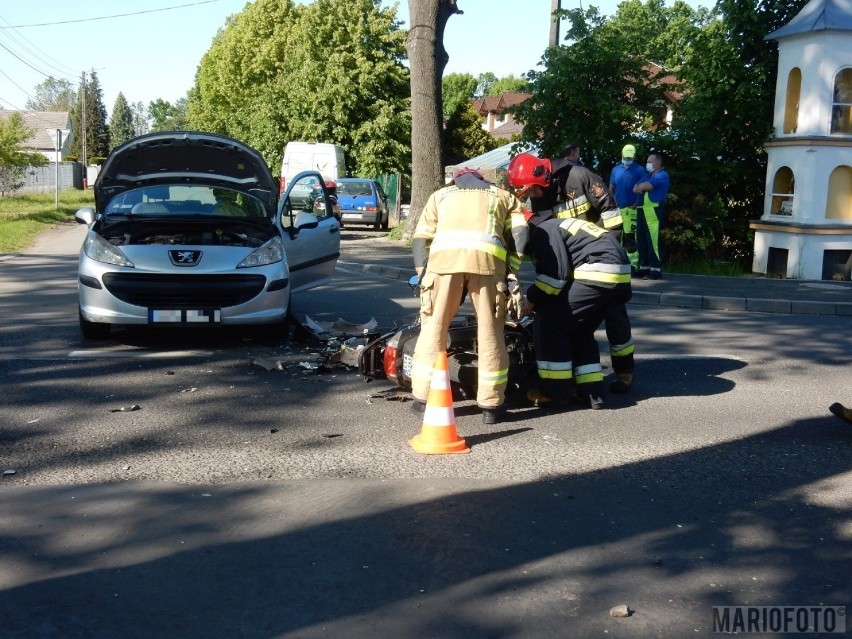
[411,169,529,424]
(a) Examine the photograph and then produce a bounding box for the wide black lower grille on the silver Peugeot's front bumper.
[103,273,266,309]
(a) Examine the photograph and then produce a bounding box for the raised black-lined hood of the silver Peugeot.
[94,131,278,216]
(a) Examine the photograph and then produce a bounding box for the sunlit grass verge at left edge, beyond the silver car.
[0,189,95,253]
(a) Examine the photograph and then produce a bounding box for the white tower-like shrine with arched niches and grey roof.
[750,0,852,280]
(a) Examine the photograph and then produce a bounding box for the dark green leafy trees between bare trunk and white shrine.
[515,0,807,269]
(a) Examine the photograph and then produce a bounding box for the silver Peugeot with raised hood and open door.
[75,131,340,339]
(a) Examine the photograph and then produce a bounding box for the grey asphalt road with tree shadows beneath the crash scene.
[0,222,852,639]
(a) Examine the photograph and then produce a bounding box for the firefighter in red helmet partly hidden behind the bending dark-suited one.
[509,153,635,393]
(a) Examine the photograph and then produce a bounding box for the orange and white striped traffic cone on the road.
[408,351,470,455]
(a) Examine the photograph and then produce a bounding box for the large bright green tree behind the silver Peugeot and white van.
[187,0,410,175]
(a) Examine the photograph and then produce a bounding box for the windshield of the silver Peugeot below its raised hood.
[104,184,267,218]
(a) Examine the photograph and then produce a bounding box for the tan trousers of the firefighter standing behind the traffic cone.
[411,270,509,408]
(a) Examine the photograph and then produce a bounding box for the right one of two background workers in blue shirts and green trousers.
[633,151,669,280]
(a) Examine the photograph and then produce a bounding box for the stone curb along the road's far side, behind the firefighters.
[337,260,852,317]
